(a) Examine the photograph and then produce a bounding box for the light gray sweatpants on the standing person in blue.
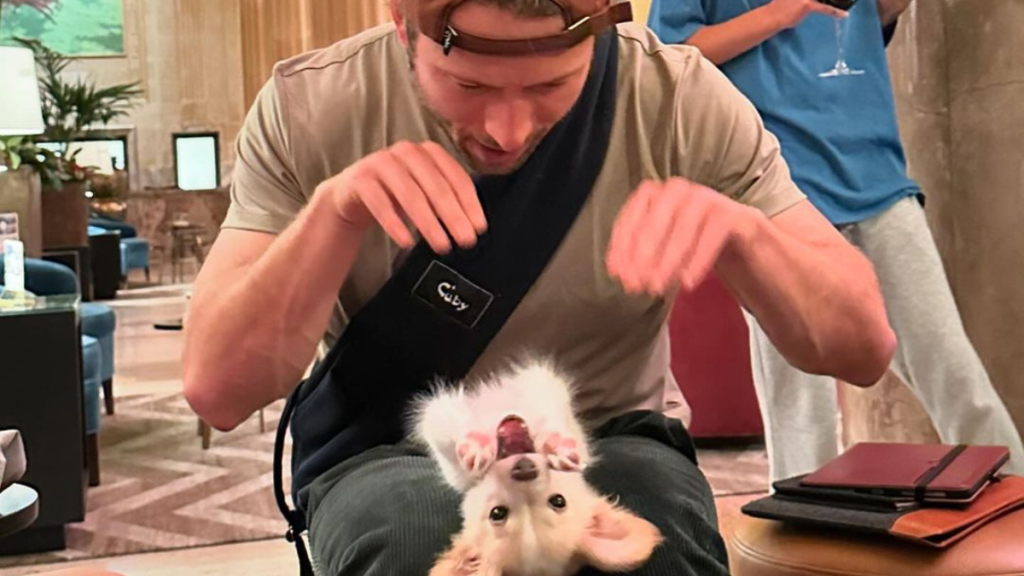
[745,198,1024,481]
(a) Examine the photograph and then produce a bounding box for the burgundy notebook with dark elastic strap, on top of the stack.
[800,443,1010,501]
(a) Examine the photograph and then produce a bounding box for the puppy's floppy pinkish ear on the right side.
[579,499,663,572]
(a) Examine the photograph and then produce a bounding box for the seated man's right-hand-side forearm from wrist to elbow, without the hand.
[716,203,895,386]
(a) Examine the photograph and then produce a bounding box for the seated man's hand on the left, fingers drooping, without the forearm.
[316,141,487,253]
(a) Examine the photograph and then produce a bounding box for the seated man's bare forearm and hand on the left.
[189,142,486,429]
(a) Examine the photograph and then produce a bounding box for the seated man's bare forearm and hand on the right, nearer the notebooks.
[607,179,895,385]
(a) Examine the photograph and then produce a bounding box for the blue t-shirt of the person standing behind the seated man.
[648,0,920,224]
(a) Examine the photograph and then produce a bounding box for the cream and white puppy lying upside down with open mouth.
[411,361,662,576]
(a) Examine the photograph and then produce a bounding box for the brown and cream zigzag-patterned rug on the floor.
[0,393,768,573]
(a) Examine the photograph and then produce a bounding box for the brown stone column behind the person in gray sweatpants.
[843,0,1024,443]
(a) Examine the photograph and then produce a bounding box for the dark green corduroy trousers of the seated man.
[307,412,728,576]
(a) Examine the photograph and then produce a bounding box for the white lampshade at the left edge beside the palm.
[0,46,45,136]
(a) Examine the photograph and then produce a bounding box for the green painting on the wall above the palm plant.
[0,0,125,57]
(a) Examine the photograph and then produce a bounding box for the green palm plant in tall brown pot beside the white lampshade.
[6,35,142,248]
